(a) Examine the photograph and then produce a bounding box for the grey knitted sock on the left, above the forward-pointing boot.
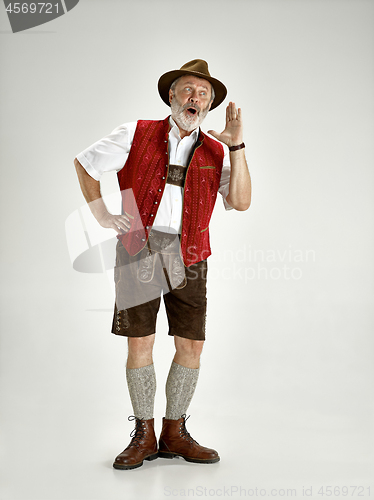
[126,363,156,420]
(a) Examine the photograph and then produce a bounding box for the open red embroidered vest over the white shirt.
[118,118,224,267]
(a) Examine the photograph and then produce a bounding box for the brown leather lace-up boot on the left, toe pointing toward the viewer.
[113,415,158,469]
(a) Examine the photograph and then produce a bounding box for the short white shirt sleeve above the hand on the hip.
[77,122,137,181]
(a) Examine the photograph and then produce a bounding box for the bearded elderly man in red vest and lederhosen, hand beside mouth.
[74,59,251,469]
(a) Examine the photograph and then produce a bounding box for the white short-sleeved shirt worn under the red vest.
[77,117,232,233]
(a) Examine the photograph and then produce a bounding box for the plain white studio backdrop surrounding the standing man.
[0,0,374,500]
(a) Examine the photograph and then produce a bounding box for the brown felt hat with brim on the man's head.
[158,59,227,110]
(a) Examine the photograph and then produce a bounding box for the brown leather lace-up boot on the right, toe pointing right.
[158,415,220,464]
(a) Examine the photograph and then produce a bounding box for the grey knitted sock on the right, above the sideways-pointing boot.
[165,361,199,420]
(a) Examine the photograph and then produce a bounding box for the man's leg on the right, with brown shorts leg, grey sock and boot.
[159,261,220,463]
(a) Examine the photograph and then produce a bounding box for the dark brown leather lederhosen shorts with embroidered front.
[112,231,207,340]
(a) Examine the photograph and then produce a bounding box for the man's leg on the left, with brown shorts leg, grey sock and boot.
[112,242,162,469]
